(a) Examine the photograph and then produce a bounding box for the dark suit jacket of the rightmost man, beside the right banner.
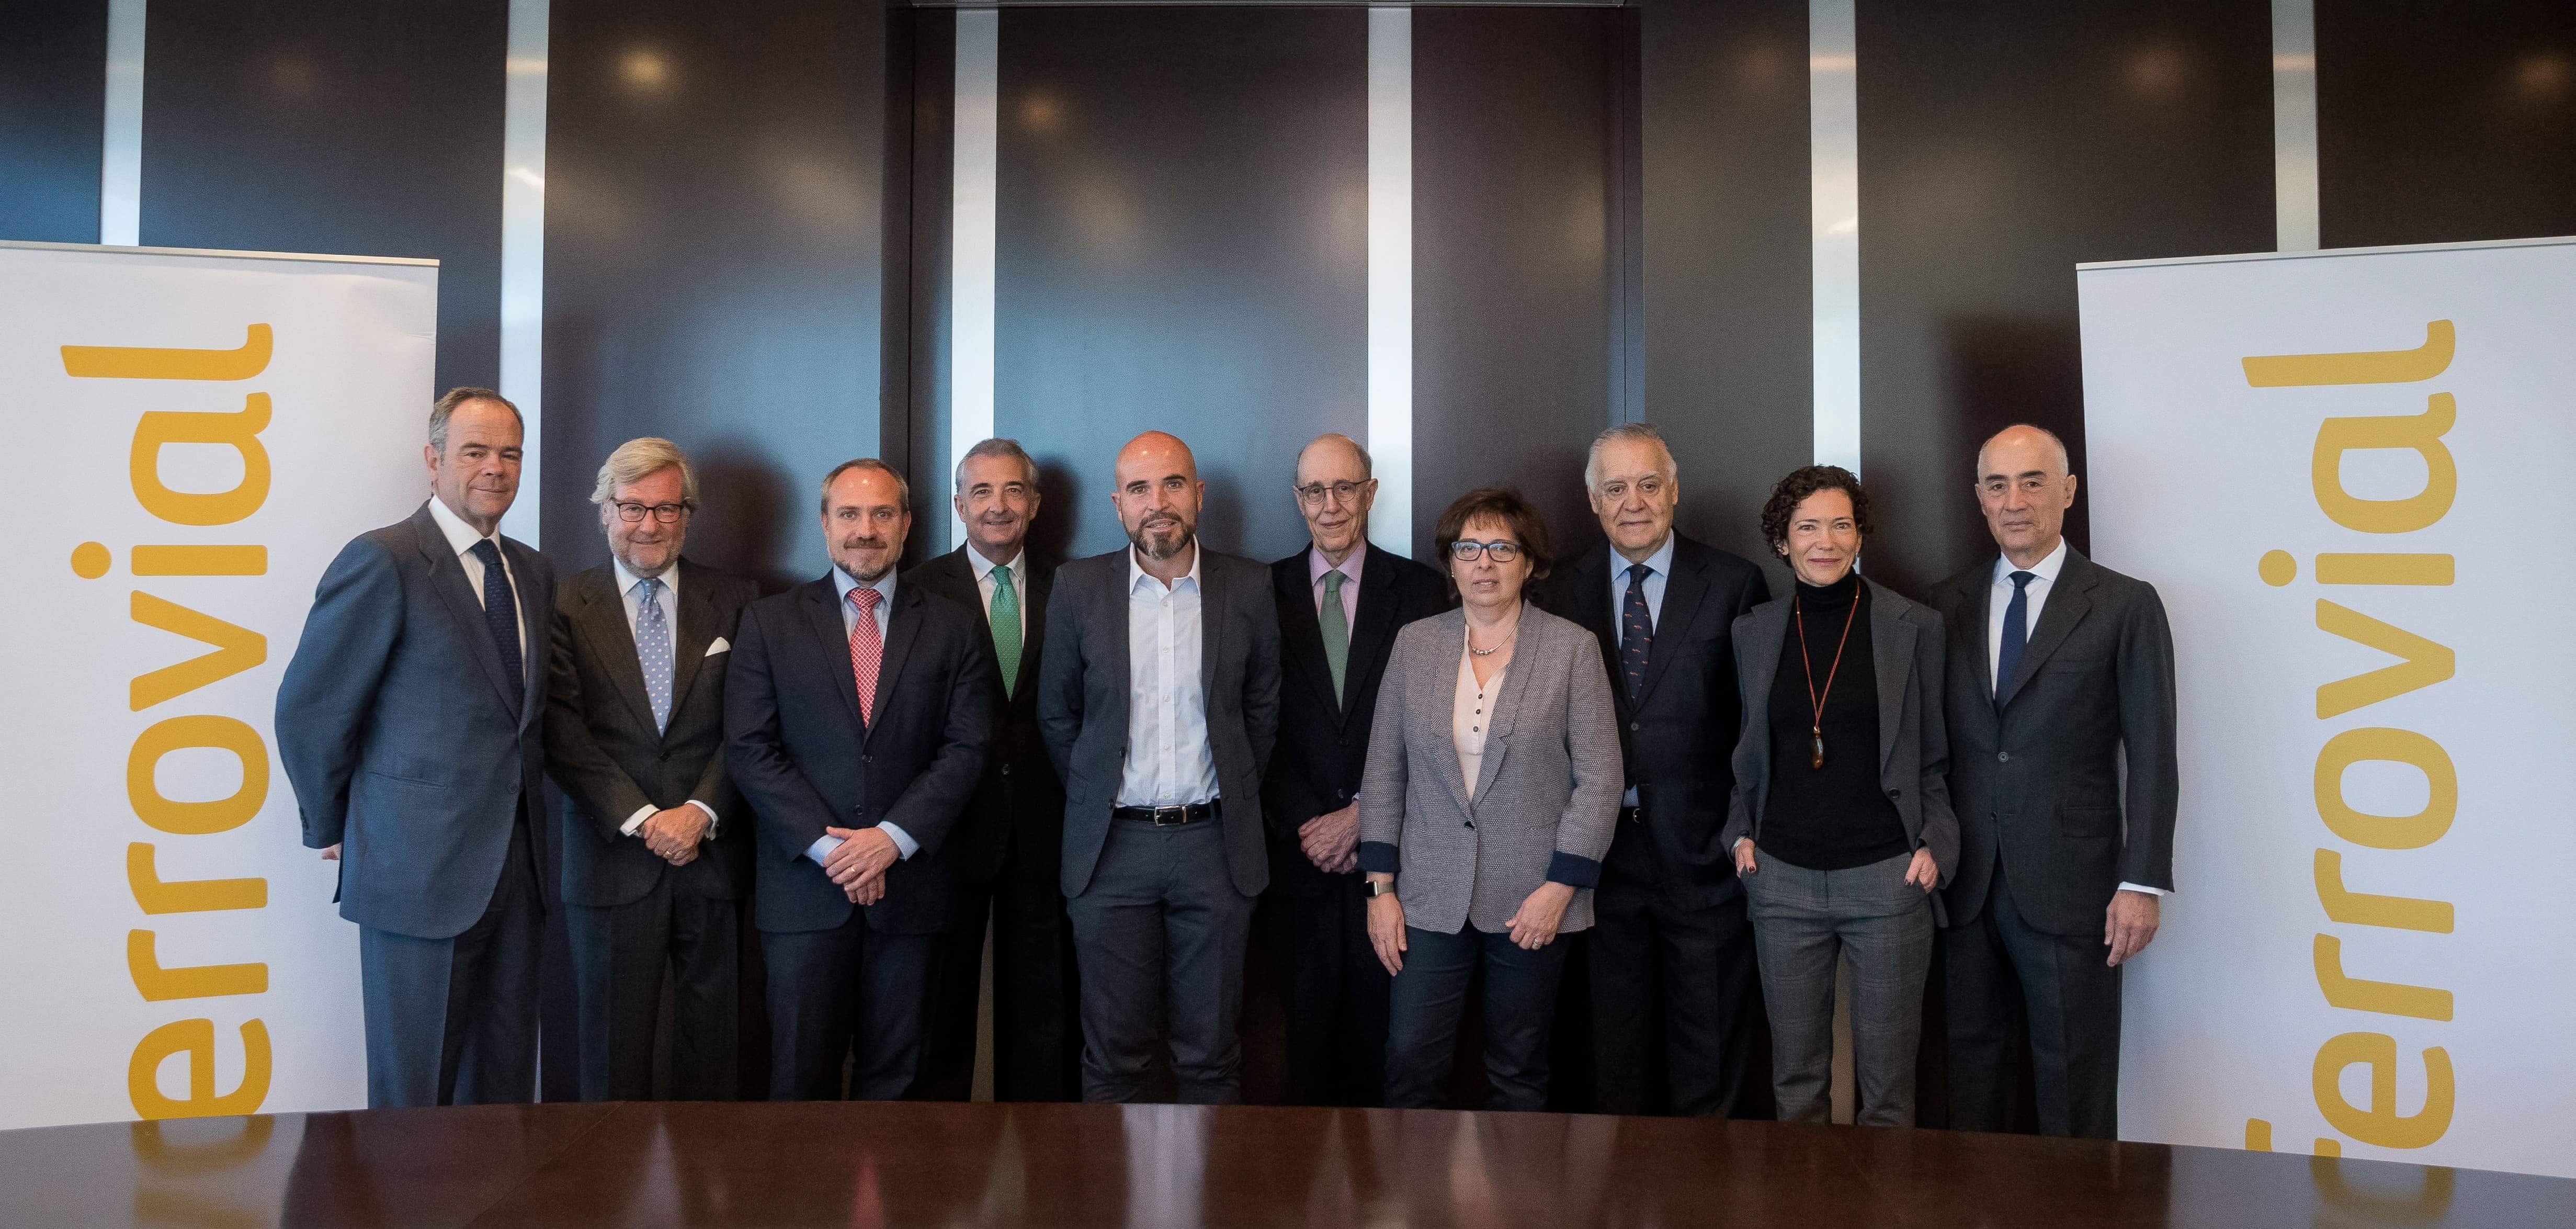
[1932,546,2182,935]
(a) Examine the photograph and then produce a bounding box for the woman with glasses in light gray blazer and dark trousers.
[1360,487,1617,1110]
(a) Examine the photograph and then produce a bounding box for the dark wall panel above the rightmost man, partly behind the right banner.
[1860,0,2275,593]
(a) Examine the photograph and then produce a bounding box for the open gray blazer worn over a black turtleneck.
[1718,577,1958,912]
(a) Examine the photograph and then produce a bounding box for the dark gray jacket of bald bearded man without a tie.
[1038,541,1280,897]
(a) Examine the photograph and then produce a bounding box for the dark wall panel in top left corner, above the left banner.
[0,0,108,242]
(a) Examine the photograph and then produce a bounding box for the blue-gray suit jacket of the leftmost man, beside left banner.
[278,502,554,938]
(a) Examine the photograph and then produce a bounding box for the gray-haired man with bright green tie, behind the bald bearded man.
[904,438,1082,1100]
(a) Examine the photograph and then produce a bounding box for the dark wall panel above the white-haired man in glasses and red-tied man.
[543,0,902,590]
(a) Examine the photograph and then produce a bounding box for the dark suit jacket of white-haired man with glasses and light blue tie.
[546,559,760,907]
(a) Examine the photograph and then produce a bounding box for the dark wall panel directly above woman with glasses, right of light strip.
[1414,8,1607,559]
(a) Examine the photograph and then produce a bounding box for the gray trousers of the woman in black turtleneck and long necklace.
[1744,848,1932,1126]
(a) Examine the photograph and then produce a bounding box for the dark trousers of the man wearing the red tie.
[760,909,935,1100]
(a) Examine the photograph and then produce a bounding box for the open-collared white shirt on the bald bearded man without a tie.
[1118,546,1216,806]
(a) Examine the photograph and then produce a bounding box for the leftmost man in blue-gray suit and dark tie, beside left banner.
[276,389,554,1106]
